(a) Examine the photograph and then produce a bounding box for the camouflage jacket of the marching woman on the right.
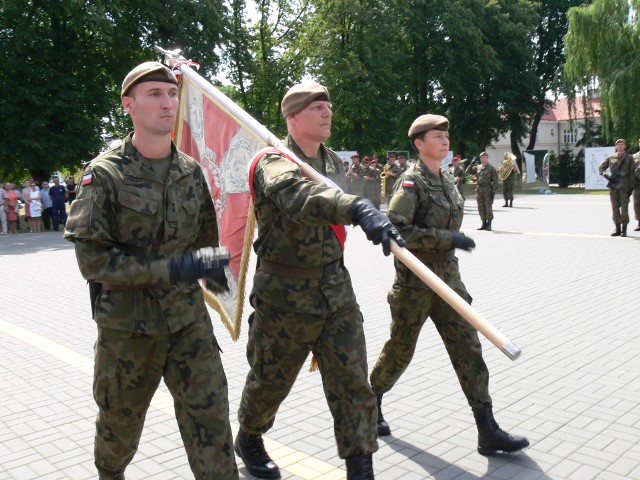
[387,160,464,285]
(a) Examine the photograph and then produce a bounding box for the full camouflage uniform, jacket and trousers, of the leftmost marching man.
[64,135,238,480]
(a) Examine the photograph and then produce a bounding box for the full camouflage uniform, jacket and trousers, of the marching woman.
[371,161,491,409]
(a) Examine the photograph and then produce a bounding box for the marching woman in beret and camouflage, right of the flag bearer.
[370,115,529,455]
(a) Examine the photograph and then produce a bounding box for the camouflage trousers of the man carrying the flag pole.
[238,269,378,458]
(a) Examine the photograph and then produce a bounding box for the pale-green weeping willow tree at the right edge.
[565,0,640,141]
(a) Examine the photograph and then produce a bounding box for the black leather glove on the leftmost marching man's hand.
[168,247,229,283]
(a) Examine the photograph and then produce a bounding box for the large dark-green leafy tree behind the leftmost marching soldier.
[0,0,225,180]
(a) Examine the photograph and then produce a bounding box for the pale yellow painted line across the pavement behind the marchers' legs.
[0,319,345,480]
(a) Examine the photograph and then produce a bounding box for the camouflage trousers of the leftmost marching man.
[93,317,238,480]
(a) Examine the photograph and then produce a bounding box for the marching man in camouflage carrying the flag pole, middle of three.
[235,83,404,480]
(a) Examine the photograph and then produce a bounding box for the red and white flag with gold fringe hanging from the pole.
[175,70,267,339]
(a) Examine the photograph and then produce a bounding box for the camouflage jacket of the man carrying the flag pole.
[253,136,356,267]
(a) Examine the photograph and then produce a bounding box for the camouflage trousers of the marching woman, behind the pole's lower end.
[371,262,492,409]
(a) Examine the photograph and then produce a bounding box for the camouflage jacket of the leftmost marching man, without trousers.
[64,131,218,335]
